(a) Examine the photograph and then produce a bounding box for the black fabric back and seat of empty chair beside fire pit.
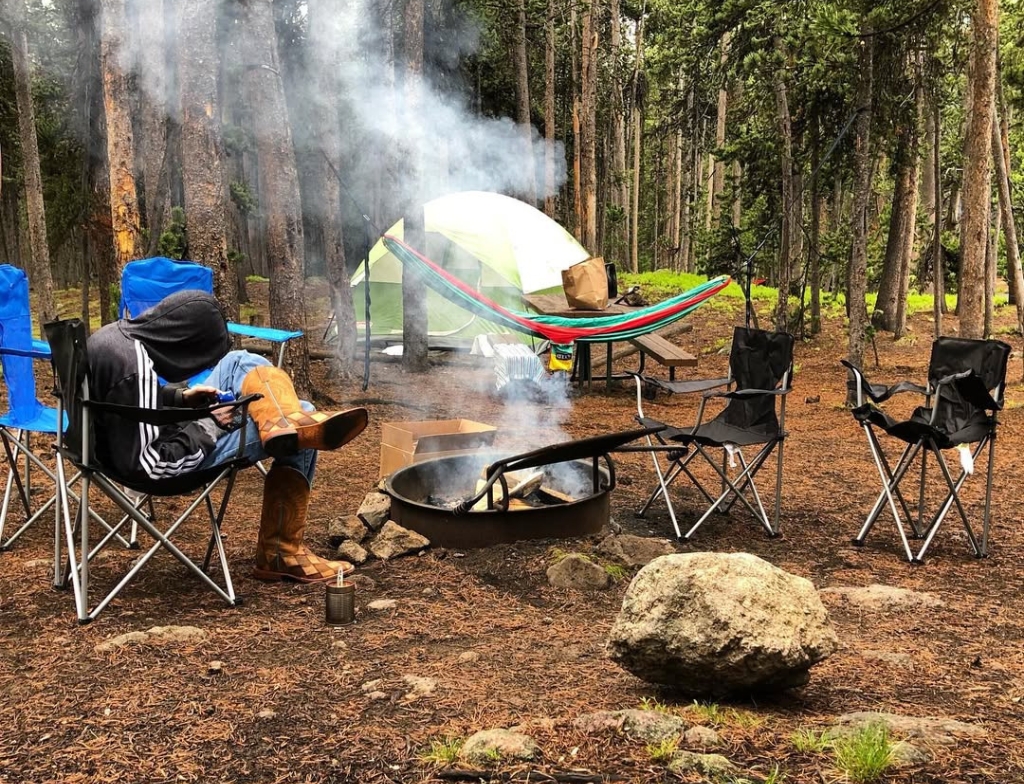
[716,326,794,435]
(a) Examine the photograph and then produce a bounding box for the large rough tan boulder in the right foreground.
[608,553,838,698]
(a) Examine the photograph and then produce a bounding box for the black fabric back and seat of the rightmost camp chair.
[924,338,1011,440]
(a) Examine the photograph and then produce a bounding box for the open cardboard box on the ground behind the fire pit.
[380,420,498,477]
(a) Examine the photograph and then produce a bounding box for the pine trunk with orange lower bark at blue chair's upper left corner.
[99,0,141,285]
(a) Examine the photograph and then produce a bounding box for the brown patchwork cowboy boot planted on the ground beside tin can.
[253,466,355,582]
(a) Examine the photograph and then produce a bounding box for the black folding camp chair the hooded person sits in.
[44,318,259,623]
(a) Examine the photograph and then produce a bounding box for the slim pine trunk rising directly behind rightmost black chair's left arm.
[846,30,874,405]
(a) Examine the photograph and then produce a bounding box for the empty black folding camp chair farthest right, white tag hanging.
[842,338,1011,563]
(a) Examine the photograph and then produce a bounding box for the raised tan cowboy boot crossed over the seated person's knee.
[242,365,369,458]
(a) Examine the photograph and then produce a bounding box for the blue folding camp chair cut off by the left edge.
[0,264,129,550]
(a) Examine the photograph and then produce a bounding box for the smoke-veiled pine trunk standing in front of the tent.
[401,0,429,373]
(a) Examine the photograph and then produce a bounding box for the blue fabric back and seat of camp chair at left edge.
[0,264,43,428]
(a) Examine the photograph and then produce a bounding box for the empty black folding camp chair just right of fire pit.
[634,326,794,540]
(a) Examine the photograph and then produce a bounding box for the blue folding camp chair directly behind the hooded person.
[119,256,302,367]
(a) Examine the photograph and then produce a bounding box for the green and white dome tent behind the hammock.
[352,190,590,346]
